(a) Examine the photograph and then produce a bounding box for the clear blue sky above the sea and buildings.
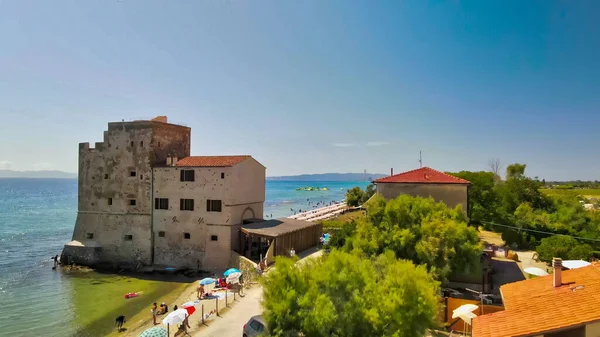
[0,0,600,180]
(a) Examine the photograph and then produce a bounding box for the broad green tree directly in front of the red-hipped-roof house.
[344,195,481,281]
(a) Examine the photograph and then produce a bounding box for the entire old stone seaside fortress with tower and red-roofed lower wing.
[63,116,266,269]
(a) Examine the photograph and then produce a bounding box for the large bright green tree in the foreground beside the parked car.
[262,250,439,337]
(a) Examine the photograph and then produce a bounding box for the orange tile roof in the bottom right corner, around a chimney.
[472,265,600,337]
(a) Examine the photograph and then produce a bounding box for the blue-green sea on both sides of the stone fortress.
[0,179,368,337]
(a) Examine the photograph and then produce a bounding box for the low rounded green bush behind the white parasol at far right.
[536,235,592,263]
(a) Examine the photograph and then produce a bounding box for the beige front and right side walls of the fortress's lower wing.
[153,159,265,270]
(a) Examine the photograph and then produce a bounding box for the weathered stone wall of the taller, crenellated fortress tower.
[64,121,190,266]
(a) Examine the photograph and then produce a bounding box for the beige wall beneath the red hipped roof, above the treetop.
[377,183,468,212]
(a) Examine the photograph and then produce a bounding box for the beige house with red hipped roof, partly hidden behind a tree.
[374,167,471,212]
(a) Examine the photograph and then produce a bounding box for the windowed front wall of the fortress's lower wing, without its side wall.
[153,167,232,270]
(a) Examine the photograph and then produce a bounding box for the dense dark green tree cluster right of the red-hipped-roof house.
[450,164,600,261]
